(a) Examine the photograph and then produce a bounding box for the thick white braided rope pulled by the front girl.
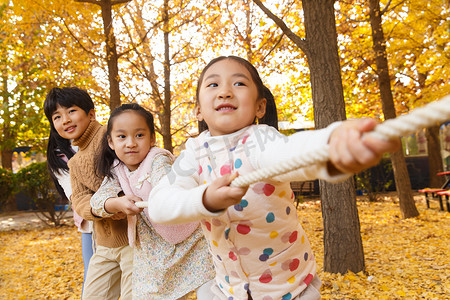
[231,95,450,187]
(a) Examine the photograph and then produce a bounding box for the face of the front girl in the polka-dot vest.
[197,59,266,136]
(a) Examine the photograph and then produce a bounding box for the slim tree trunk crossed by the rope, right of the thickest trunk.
[369,0,419,218]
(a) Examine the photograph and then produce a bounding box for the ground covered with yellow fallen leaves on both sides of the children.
[0,196,450,299]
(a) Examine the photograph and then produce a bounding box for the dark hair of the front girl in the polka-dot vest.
[195,55,278,132]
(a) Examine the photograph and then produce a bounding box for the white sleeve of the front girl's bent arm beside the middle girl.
[148,140,224,224]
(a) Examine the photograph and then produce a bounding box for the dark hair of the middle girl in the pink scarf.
[96,103,155,178]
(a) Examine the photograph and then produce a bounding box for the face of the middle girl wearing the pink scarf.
[108,111,155,171]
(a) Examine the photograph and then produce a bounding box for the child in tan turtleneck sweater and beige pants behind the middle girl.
[44,87,133,299]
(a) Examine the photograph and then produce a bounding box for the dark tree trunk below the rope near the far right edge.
[425,126,445,188]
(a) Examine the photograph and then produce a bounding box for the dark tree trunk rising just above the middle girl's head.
[100,0,121,110]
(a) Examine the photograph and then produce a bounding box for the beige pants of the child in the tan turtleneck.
[82,245,133,300]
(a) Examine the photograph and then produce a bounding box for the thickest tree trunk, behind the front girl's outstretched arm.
[302,0,365,273]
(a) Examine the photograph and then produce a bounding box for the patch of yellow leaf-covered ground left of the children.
[0,226,83,299]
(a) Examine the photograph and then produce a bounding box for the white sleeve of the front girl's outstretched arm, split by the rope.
[247,122,351,182]
